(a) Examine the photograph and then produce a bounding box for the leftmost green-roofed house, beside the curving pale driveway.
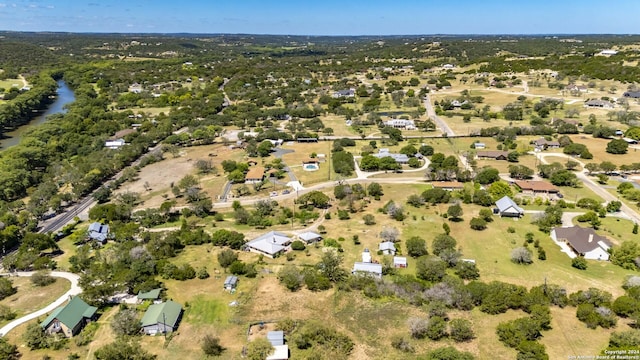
[40,296,98,338]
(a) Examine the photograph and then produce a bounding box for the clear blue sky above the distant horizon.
[0,0,640,35]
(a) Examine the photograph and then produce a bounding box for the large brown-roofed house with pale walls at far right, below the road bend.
[551,226,611,261]
